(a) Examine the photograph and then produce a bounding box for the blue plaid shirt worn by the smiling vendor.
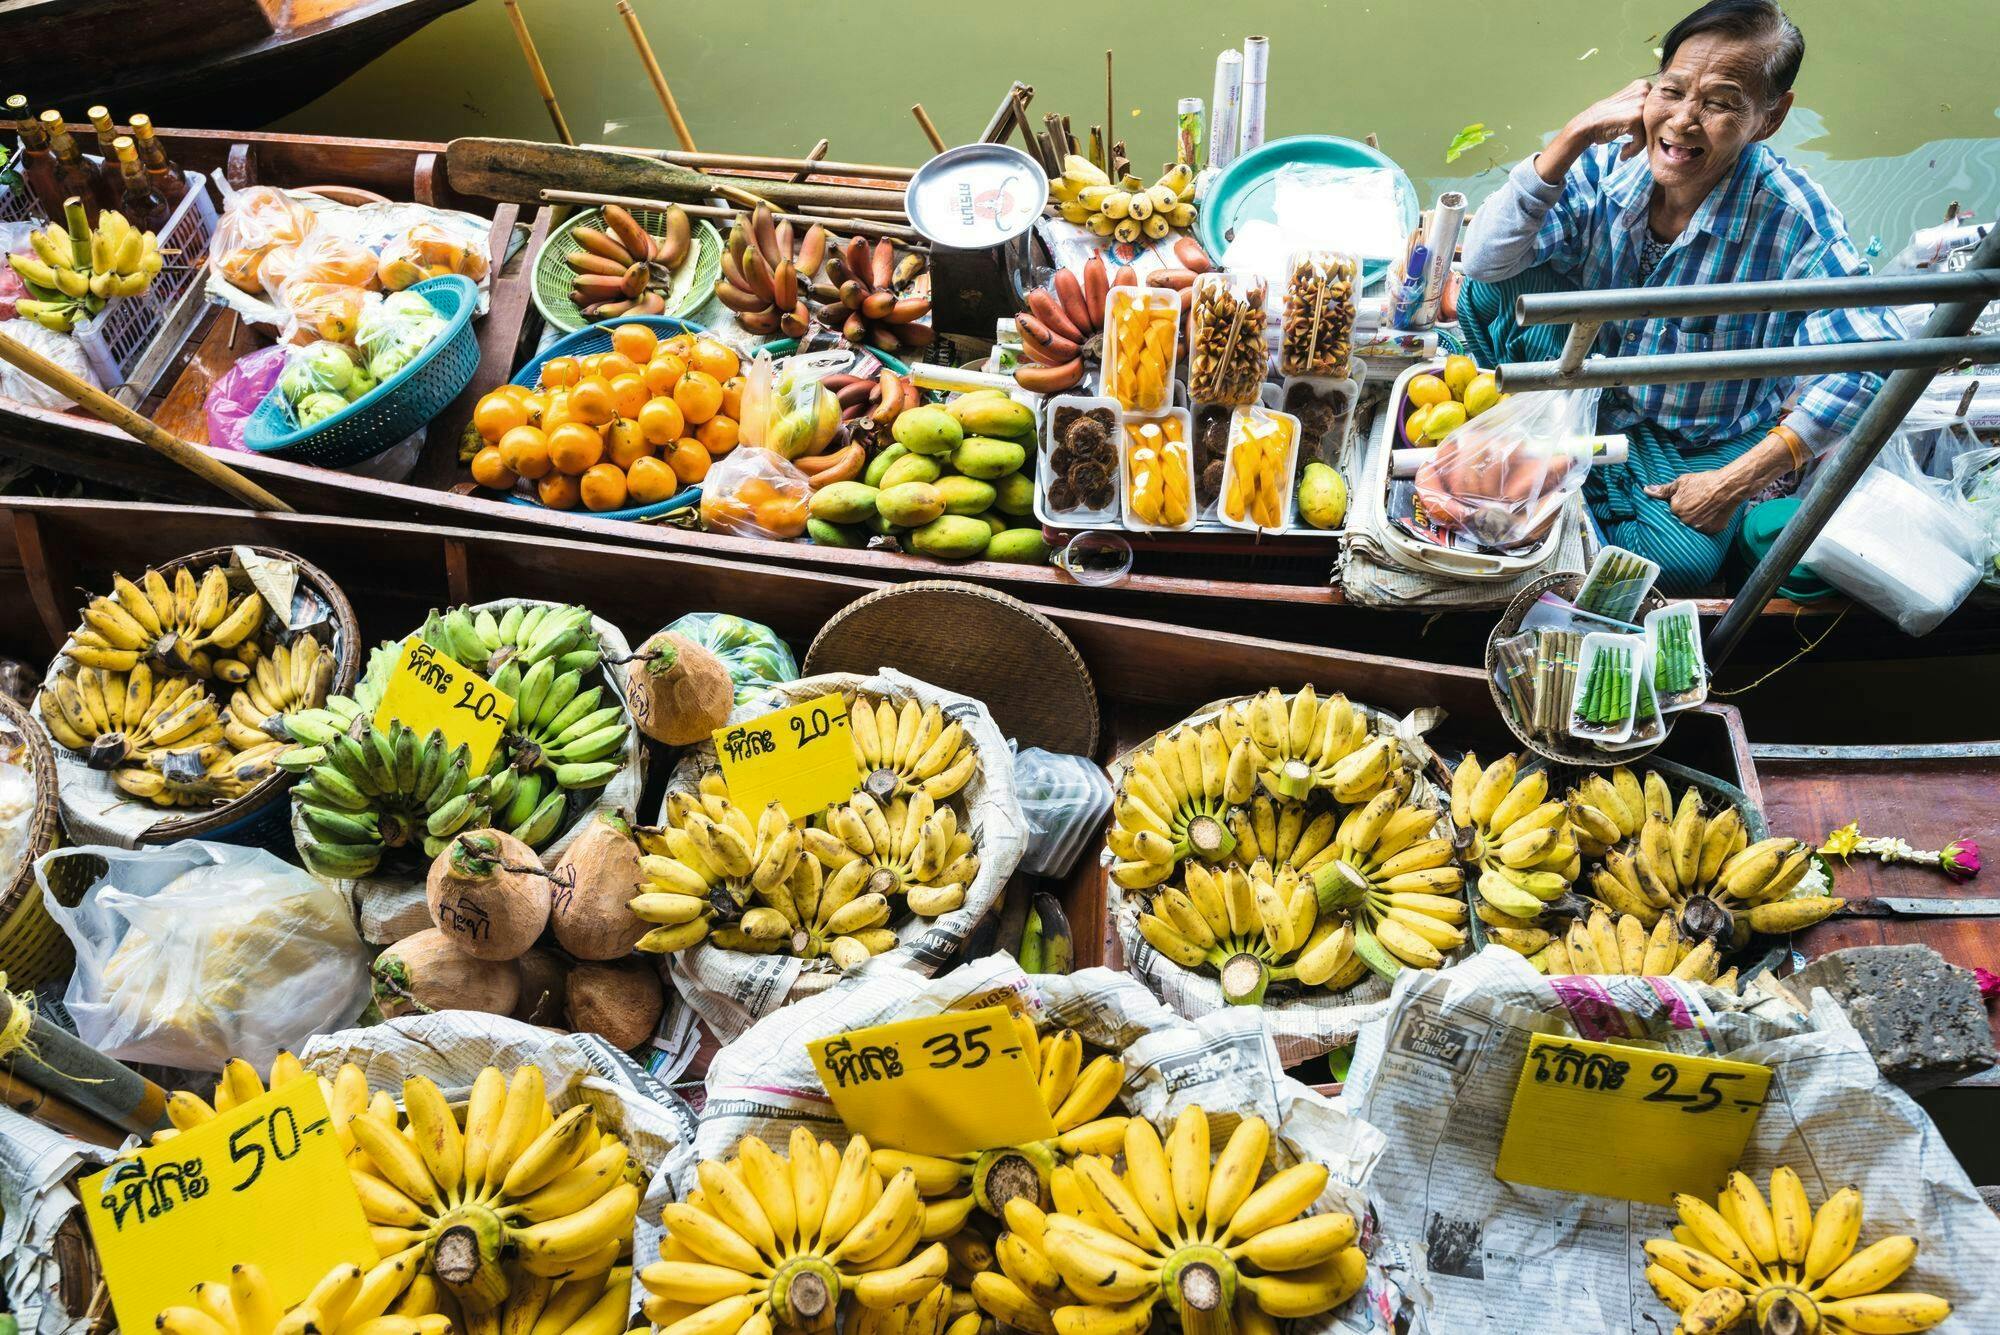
[1464,142,1904,454]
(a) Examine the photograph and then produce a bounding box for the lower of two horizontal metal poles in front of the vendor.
[1494,333,2000,394]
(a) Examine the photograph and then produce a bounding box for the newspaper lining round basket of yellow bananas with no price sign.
[1100,695,1444,1065]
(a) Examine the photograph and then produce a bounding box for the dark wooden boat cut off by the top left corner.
[0,0,470,128]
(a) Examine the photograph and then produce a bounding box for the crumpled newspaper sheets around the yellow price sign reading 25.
[1342,945,2000,1335]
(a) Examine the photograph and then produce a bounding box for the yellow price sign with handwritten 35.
[806,1005,1056,1155]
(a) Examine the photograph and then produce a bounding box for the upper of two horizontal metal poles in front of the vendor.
[1514,270,2000,324]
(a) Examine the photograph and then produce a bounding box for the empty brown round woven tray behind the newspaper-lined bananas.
[800,580,1098,755]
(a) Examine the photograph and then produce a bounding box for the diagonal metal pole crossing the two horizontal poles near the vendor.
[1702,228,2000,669]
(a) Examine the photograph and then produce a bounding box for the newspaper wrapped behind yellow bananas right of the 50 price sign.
[300,1011,696,1311]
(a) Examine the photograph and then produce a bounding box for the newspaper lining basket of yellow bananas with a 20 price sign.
[656,668,1028,1043]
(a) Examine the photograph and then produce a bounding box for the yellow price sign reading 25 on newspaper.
[1494,1033,1770,1205]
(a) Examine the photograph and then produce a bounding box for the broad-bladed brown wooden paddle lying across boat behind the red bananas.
[444,138,902,210]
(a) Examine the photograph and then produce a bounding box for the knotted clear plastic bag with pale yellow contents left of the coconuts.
[36,841,368,1071]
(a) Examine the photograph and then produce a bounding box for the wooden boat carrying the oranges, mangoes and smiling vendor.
[0,130,2000,664]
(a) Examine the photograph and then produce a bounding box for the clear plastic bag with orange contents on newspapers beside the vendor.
[1416,390,1598,548]
